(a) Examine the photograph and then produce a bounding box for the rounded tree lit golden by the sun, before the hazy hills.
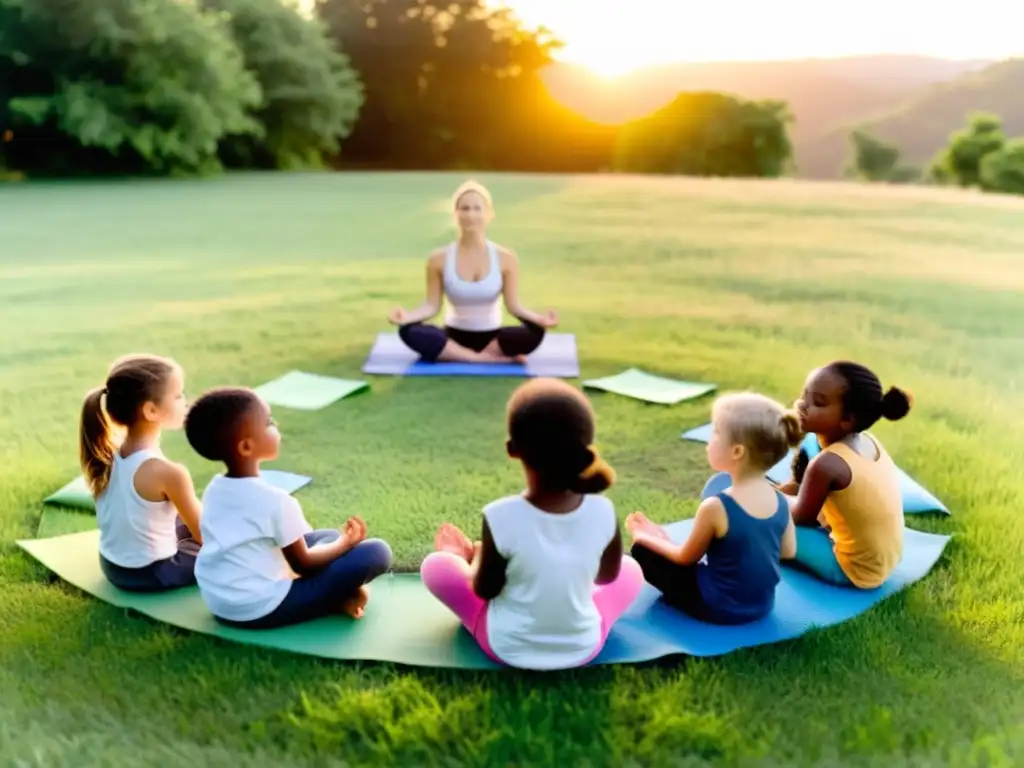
[613,92,793,177]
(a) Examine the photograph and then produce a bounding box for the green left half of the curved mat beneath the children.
[17,529,498,669]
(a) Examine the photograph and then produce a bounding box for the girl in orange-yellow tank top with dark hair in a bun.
[782,361,911,589]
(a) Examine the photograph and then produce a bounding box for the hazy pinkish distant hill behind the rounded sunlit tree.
[545,55,988,177]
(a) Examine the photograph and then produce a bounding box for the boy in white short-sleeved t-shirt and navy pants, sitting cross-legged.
[185,388,391,629]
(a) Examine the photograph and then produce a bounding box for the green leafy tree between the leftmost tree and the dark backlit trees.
[203,0,362,169]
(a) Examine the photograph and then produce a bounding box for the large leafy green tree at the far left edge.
[0,0,261,174]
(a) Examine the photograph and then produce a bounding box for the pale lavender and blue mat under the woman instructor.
[362,333,580,379]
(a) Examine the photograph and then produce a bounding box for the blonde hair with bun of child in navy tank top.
[712,392,804,470]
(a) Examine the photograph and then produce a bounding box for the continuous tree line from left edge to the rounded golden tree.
[0,0,792,176]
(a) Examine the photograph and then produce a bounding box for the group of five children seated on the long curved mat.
[80,180,911,670]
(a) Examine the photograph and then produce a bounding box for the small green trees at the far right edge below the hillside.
[850,113,1024,195]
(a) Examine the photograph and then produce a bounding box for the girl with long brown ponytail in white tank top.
[79,354,202,592]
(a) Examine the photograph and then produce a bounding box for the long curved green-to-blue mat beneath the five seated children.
[17,520,949,670]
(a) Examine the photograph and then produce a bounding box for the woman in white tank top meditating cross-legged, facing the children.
[388,181,558,362]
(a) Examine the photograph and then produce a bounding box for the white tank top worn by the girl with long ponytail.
[96,449,178,568]
